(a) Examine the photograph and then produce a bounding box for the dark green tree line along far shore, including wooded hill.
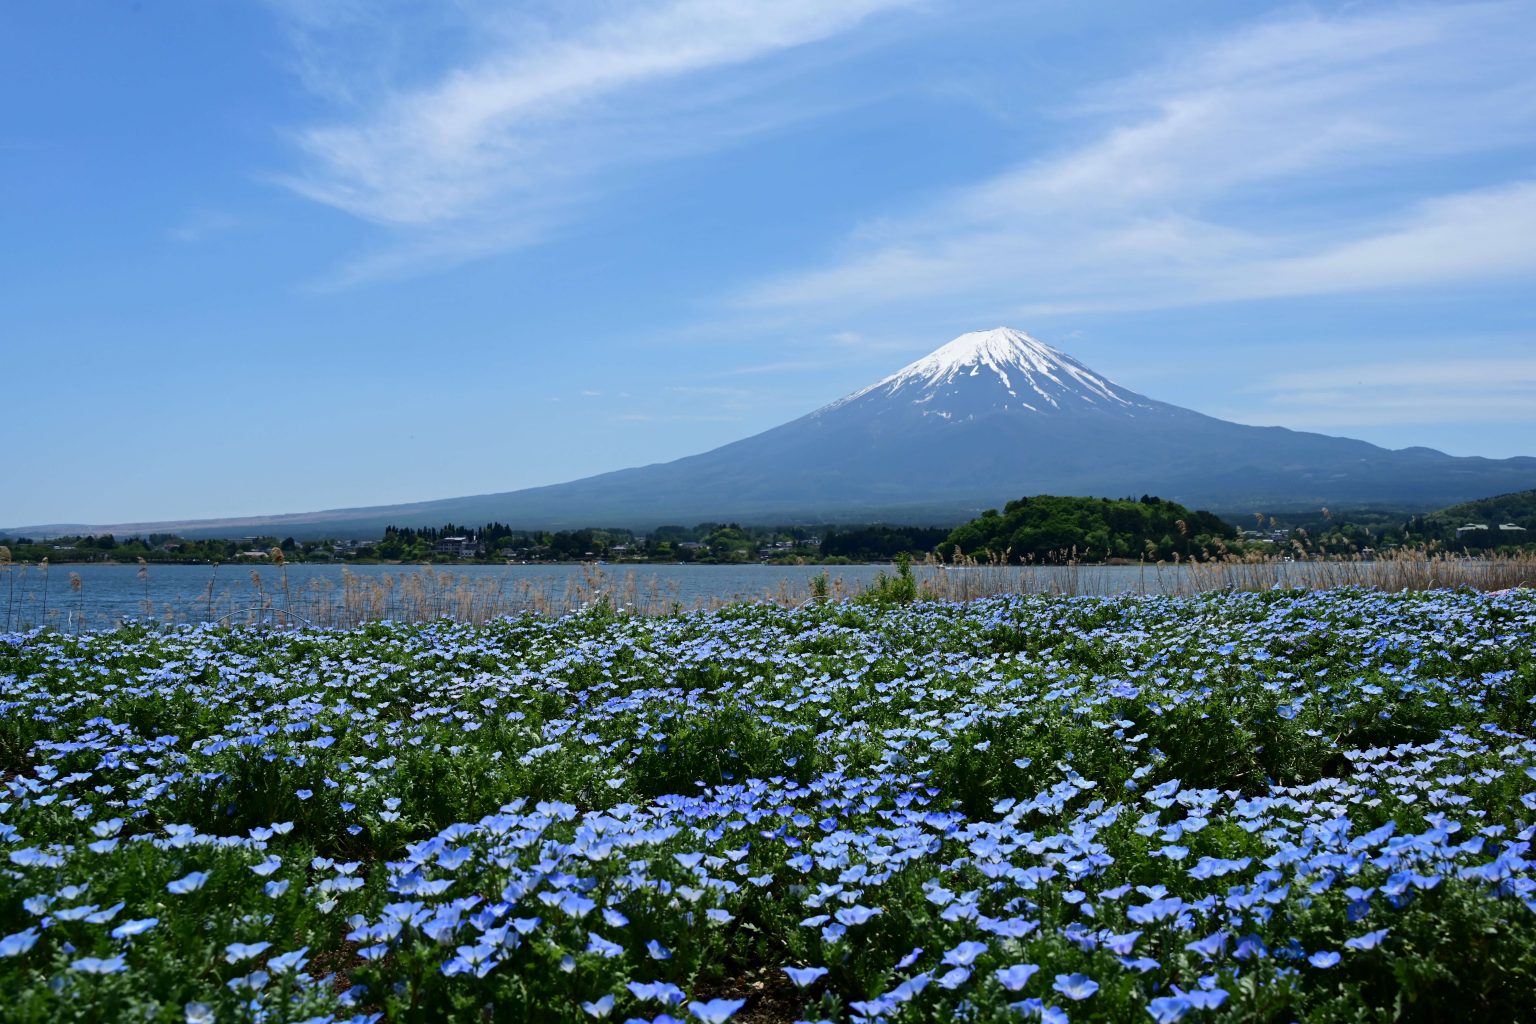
[0,490,1536,565]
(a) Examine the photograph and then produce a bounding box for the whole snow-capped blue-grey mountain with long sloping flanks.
[12,327,1536,537]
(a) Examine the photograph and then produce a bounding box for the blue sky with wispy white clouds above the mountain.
[0,0,1536,525]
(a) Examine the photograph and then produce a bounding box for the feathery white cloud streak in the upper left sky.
[268,0,911,282]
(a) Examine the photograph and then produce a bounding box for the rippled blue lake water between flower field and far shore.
[0,563,1222,629]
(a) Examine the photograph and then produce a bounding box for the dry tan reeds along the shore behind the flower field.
[5,551,1536,629]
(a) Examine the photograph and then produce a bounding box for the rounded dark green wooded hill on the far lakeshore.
[938,494,1236,562]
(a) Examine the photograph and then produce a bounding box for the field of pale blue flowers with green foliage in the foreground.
[0,591,1536,1024]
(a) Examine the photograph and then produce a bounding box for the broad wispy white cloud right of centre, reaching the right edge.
[733,3,1536,316]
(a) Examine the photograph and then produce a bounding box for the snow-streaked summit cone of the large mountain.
[829,327,1146,419]
